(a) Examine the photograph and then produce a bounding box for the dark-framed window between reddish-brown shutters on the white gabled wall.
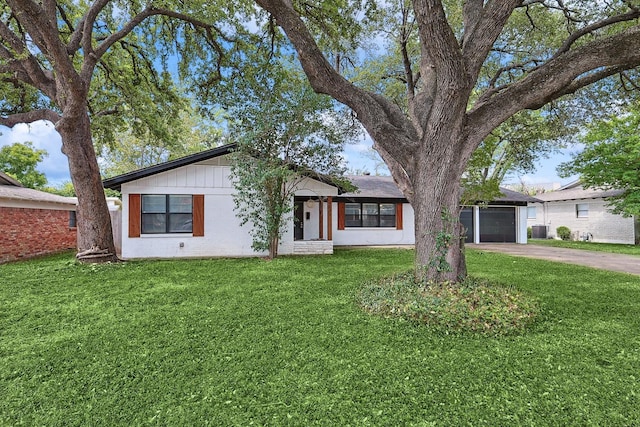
[142,194,193,234]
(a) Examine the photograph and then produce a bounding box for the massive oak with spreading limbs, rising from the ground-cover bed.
[251,0,640,281]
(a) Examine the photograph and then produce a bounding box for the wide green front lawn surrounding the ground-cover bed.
[0,250,640,426]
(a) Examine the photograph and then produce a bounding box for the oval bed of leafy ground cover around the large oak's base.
[357,272,538,336]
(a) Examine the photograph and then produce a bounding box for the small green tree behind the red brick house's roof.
[0,142,48,189]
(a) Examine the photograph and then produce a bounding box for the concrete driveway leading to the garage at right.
[466,243,640,275]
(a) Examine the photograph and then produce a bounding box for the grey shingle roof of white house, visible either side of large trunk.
[338,175,540,205]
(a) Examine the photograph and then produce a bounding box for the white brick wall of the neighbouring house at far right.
[527,199,635,245]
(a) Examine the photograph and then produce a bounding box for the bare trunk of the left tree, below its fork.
[56,111,118,262]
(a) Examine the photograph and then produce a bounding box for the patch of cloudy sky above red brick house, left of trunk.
[0,120,71,186]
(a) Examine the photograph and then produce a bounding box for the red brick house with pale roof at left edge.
[0,172,77,263]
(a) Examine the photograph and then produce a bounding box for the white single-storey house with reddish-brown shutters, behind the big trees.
[104,145,535,259]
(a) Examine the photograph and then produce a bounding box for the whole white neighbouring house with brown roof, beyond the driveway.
[527,181,640,245]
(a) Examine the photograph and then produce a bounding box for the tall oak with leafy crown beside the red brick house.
[0,0,230,261]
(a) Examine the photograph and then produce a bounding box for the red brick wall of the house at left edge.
[0,207,77,263]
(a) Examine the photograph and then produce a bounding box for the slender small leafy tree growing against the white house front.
[230,64,359,258]
